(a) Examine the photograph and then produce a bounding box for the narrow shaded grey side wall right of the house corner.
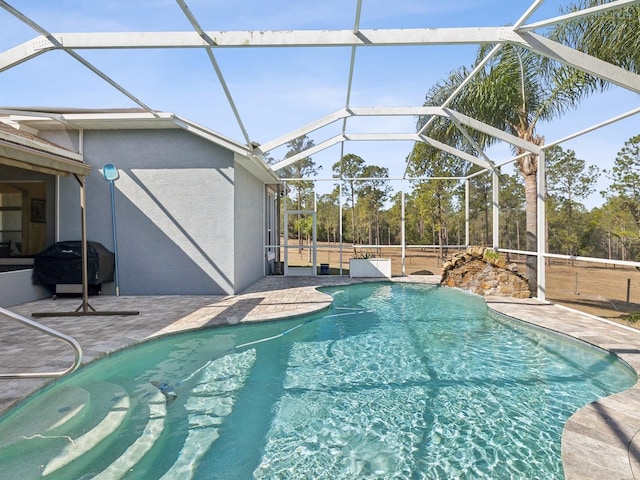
[234,158,265,292]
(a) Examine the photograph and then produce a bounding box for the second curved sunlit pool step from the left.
[42,383,130,476]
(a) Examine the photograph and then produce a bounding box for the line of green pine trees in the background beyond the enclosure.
[278,135,640,261]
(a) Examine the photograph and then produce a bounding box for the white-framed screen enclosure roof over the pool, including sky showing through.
[0,0,640,181]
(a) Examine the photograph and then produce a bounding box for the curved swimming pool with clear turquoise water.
[0,283,636,479]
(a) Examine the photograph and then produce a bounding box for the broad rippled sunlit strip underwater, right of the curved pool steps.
[162,350,256,480]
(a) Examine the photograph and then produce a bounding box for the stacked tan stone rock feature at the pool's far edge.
[440,247,531,298]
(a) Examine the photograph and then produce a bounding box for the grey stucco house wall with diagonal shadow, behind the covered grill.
[60,130,235,295]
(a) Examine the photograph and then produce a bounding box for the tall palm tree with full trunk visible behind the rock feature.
[418,44,597,291]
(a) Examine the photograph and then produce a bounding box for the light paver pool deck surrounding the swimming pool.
[0,276,640,480]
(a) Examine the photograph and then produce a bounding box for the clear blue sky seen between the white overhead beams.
[0,0,640,207]
